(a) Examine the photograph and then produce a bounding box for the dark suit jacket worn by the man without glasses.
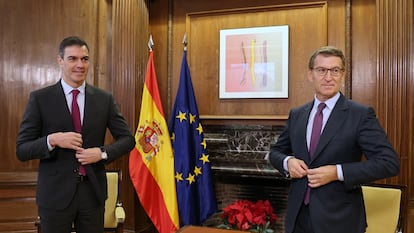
[16,81,135,209]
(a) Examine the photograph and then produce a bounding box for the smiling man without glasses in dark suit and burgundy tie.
[16,37,135,233]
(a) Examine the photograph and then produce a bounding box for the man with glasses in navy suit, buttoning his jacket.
[269,46,400,233]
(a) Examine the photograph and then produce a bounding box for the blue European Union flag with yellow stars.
[169,50,217,226]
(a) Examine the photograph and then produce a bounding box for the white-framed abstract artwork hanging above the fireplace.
[219,25,289,99]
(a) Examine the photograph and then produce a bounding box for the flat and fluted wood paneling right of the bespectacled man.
[351,0,414,216]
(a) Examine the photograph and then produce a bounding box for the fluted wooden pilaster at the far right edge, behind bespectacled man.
[375,0,414,209]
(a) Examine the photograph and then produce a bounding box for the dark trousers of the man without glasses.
[39,181,104,233]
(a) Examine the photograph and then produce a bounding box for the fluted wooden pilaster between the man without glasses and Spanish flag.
[106,0,149,231]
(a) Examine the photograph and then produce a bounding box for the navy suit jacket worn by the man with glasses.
[269,94,400,233]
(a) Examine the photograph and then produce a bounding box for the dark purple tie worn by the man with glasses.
[303,103,326,205]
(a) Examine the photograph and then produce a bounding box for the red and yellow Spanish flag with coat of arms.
[129,50,179,233]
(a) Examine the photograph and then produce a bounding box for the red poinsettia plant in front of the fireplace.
[218,200,279,233]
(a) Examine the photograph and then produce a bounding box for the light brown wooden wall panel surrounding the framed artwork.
[169,0,346,122]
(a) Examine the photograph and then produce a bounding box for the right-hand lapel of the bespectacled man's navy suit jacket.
[312,95,349,161]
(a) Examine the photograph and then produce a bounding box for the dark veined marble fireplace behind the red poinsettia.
[203,125,290,232]
